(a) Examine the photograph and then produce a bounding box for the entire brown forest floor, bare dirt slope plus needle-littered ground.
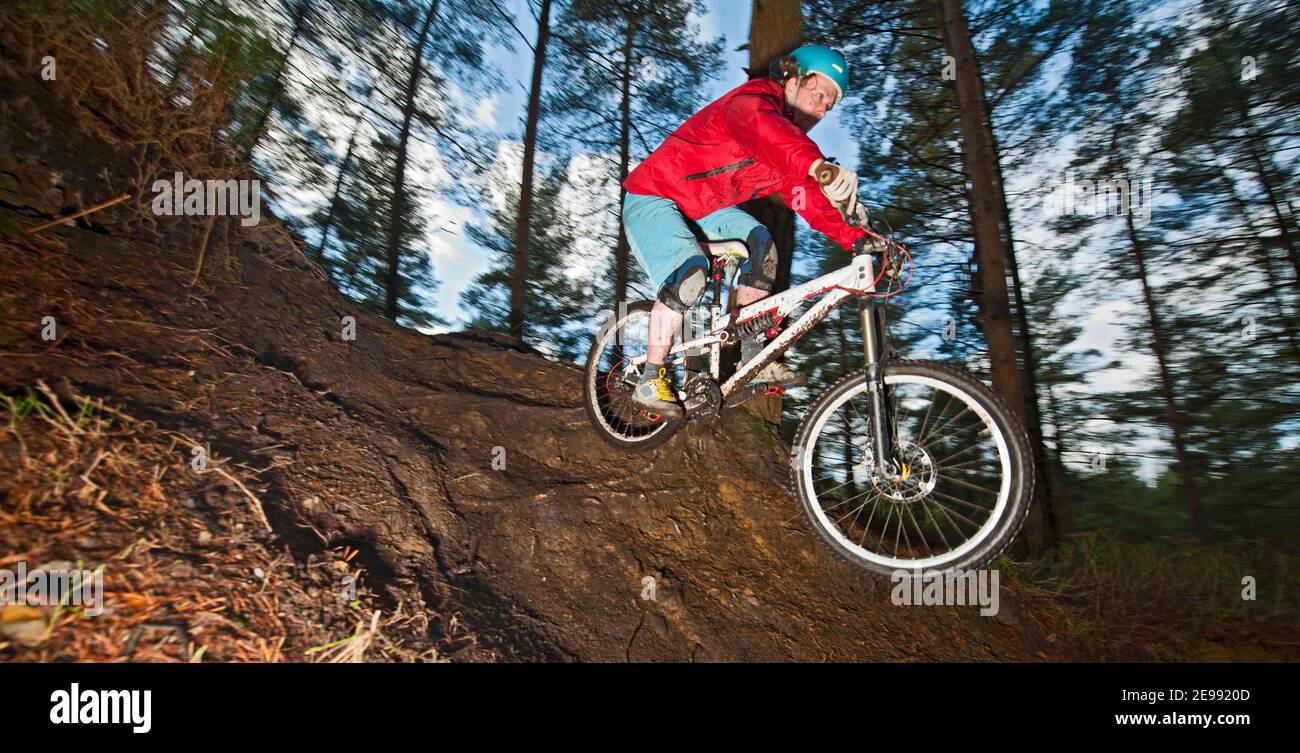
[0,212,1296,661]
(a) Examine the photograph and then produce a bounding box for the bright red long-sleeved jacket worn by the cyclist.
[623,78,866,248]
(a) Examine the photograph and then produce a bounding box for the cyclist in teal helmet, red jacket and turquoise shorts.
[623,44,866,419]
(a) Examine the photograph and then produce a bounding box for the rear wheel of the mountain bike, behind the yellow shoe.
[582,300,685,453]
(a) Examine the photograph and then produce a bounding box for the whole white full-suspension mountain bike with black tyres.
[584,196,1035,577]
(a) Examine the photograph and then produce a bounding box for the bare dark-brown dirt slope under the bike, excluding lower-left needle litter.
[0,197,1092,661]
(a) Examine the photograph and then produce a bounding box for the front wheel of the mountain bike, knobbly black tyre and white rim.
[790,360,1034,577]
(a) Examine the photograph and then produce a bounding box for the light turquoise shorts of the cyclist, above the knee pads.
[623,194,762,293]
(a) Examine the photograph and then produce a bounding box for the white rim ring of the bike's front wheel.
[800,375,1011,570]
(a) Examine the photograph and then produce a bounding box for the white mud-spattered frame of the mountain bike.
[625,254,875,399]
